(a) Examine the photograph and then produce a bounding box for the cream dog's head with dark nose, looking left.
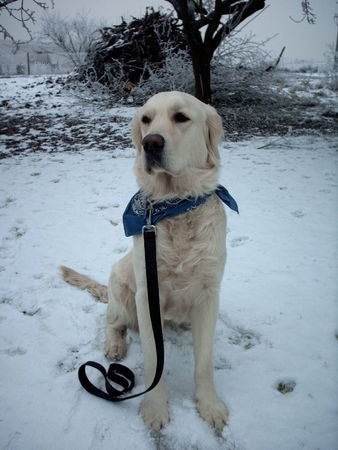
[132,92,222,197]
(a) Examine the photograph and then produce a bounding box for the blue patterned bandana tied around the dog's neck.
[123,184,239,237]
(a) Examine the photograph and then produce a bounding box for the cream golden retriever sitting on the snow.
[61,92,232,431]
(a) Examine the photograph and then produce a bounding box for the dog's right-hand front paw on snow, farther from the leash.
[196,395,229,430]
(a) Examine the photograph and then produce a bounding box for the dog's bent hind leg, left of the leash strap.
[104,253,137,359]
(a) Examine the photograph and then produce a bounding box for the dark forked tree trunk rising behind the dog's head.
[166,0,265,103]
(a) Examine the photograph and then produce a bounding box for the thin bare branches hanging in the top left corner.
[0,0,54,48]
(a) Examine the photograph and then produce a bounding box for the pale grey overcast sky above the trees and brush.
[0,0,337,61]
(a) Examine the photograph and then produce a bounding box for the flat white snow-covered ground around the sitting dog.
[0,75,338,450]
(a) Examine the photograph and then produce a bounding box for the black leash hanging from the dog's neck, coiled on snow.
[78,218,164,402]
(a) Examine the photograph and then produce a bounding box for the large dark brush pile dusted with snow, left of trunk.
[78,8,187,90]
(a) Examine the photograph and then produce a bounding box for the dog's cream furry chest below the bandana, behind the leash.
[133,196,226,323]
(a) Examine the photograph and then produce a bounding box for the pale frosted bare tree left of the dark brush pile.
[41,13,102,67]
